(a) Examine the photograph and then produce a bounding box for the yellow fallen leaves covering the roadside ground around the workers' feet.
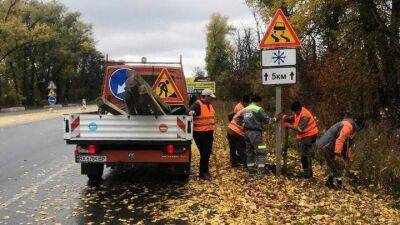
[151,126,400,224]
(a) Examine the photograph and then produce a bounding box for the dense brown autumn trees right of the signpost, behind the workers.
[246,0,400,127]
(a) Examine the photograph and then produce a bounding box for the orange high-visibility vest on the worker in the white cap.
[193,100,215,132]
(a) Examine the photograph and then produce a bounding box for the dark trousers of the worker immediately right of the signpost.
[297,135,317,177]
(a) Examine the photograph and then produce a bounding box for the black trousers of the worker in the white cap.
[193,131,214,174]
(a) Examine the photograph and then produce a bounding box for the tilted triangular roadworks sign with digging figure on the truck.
[153,68,183,103]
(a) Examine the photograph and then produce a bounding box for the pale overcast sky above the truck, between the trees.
[60,0,254,75]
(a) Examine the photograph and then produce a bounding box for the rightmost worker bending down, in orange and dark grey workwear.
[316,119,363,189]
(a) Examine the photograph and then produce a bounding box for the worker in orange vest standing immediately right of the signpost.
[283,101,318,178]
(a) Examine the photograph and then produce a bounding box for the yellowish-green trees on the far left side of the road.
[0,0,103,107]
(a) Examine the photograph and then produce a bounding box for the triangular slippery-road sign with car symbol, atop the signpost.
[260,9,300,48]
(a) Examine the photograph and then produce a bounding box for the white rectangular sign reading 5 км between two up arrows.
[262,67,296,85]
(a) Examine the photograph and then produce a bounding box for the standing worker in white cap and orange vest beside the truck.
[189,89,215,180]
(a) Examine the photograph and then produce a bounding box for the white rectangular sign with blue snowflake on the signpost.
[262,48,296,66]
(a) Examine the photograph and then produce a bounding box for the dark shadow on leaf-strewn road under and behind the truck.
[74,168,189,224]
